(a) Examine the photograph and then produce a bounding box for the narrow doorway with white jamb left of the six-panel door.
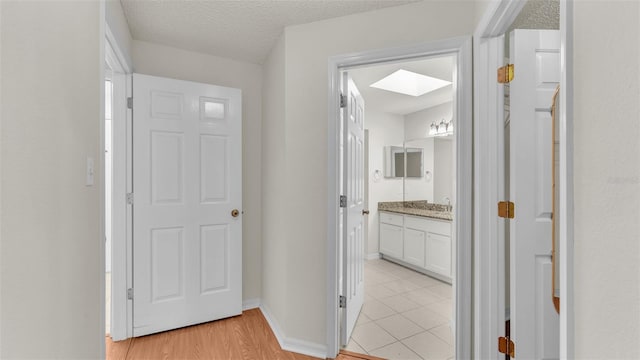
[102,26,132,341]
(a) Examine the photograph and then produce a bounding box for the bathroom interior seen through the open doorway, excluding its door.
[340,55,457,358]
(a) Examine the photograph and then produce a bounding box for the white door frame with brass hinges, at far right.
[474,0,574,359]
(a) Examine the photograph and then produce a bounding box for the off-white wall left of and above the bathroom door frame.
[263,1,474,344]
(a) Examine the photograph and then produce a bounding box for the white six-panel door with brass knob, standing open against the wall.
[133,74,242,336]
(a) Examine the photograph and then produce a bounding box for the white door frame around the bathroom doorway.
[327,37,473,359]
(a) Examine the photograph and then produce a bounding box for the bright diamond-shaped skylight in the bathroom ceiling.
[371,69,451,96]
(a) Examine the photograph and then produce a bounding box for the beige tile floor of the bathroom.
[346,259,454,360]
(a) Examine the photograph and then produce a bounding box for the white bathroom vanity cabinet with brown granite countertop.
[378,201,453,283]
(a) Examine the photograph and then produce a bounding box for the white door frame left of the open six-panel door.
[101,24,133,341]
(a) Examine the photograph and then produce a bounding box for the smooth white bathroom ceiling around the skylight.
[349,56,453,115]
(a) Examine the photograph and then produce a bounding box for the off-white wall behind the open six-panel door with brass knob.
[132,40,262,300]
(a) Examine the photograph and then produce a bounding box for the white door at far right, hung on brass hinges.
[509,30,560,359]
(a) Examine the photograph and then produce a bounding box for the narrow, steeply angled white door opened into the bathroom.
[341,72,364,345]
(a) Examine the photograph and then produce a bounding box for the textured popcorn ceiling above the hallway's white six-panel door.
[120,0,418,64]
